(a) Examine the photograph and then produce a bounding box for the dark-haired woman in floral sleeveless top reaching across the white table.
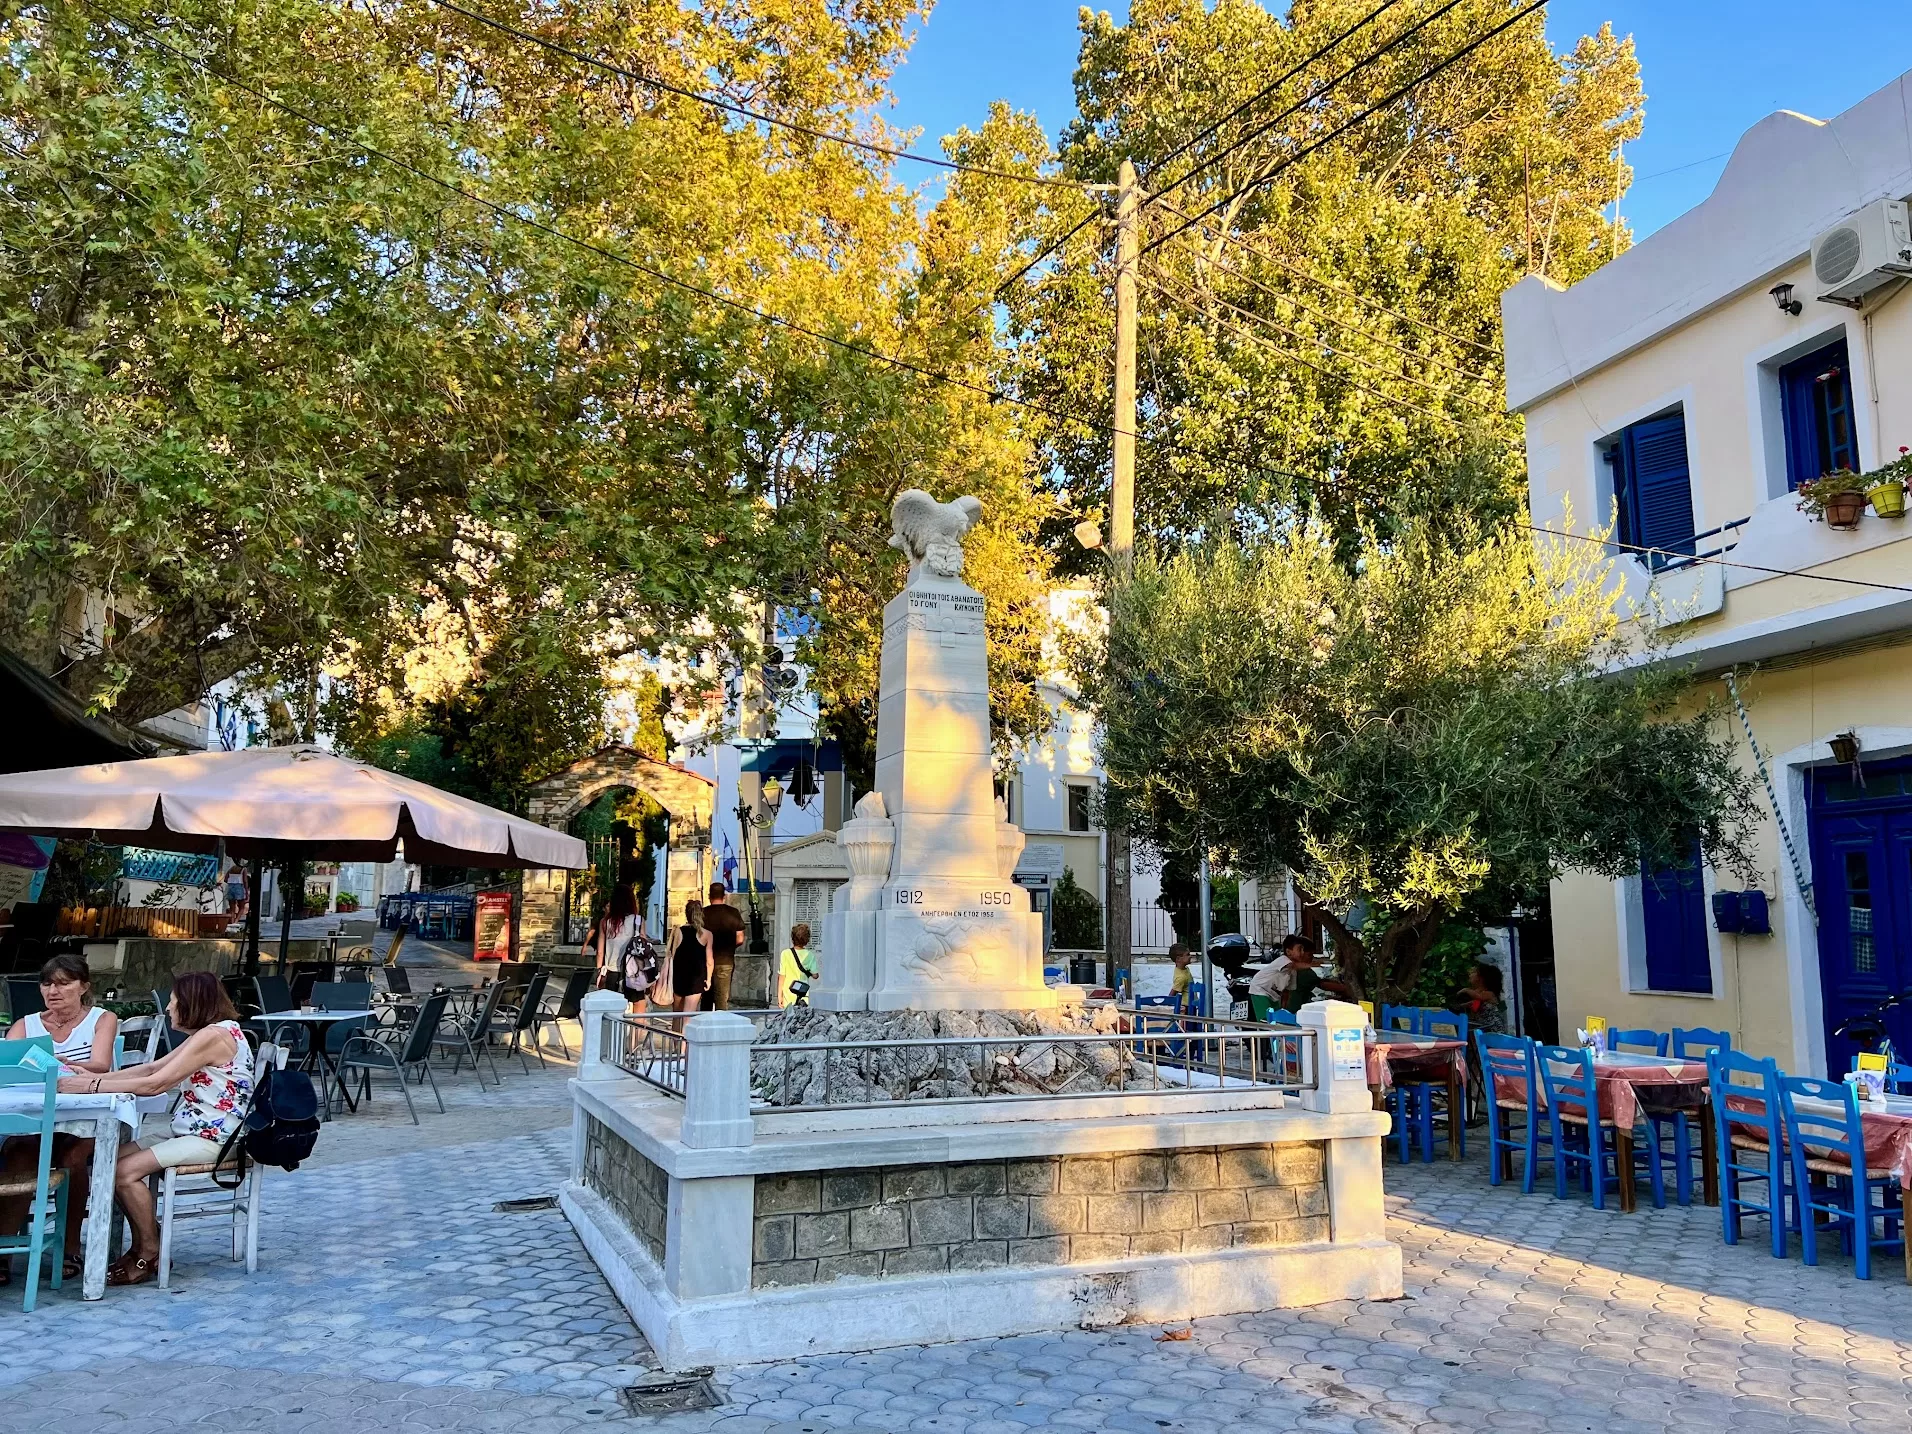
[59,971,252,1285]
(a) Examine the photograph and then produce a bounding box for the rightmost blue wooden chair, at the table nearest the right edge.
[1780,1075,1906,1279]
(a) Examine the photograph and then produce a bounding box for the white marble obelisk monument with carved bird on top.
[813,489,1055,1011]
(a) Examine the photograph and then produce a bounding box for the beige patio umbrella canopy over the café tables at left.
[0,748,589,971]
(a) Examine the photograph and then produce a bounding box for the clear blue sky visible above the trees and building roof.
[889,0,1912,235]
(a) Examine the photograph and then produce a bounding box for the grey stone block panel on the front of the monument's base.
[750,1141,1329,1285]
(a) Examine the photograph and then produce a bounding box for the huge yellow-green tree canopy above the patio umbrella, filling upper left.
[0,0,1044,776]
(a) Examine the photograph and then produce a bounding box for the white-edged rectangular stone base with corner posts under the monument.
[560,992,1401,1369]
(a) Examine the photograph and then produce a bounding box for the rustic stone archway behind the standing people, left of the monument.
[518,742,717,960]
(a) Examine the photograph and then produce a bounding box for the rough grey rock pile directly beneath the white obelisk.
[750,1006,1151,1107]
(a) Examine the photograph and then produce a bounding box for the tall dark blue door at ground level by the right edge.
[1807,761,1912,1076]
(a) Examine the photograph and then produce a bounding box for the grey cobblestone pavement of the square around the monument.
[0,1042,1912,1434]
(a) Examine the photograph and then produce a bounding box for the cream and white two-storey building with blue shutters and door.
[1501,75,1912,1075]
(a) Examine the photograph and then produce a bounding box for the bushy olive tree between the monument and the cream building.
[1078,524,1753,1000]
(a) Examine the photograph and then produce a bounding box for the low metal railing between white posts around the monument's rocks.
[602,1008,1319,1115]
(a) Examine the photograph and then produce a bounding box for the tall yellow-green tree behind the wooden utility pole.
[958,0,1642,550]
